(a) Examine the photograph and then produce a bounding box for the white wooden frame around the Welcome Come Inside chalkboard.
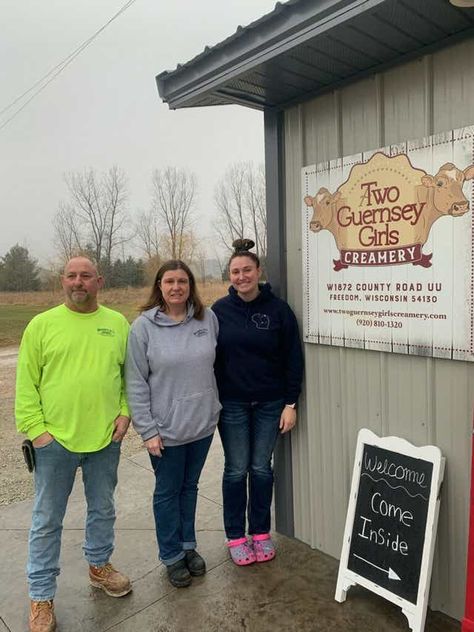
[334,428,445,632]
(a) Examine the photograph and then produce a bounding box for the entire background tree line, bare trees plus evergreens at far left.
[0,162,266,291]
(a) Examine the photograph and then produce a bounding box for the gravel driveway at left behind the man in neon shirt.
[0,347,142,505]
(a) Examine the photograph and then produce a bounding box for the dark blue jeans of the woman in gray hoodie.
[150,435,213,566]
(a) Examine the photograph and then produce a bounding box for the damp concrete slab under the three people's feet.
[0,440,460,632]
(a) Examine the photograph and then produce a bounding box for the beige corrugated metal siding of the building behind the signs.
[285,40,474,619]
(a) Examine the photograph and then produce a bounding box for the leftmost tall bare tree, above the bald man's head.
[53,166,129,266]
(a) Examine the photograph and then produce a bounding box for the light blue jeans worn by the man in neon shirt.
[27,440,120,601]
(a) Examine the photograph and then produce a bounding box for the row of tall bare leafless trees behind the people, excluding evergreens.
[53,163,266,268]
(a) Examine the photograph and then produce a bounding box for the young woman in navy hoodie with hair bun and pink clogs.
[212,239,303,566]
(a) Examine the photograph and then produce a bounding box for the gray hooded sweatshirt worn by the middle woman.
[125,306,221,447]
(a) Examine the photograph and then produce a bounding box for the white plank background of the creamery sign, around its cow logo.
[301,126,474,362]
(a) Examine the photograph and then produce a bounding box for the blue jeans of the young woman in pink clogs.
[219,399,284,540]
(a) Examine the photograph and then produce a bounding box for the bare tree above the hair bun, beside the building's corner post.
[214,162,266,256]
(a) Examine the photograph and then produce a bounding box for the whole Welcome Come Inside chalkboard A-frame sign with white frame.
[336,429,444,631]
